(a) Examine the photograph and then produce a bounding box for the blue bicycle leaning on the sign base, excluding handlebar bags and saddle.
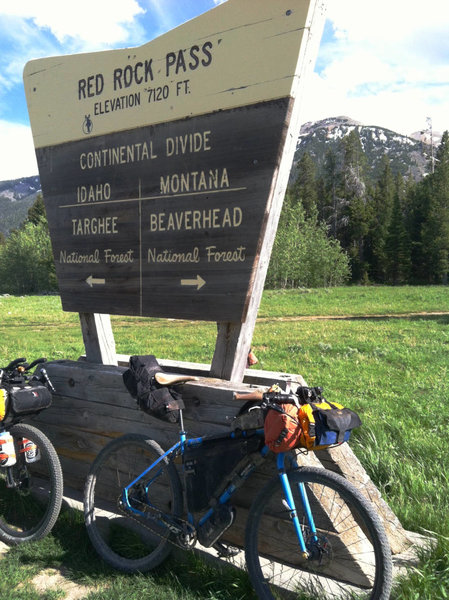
[84,377,392,600]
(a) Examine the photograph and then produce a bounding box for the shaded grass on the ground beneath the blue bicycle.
[11,509,256,600]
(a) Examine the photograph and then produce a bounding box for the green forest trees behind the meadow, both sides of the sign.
[0,129,449,294]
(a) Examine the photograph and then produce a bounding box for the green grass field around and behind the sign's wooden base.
[0,287,449,600]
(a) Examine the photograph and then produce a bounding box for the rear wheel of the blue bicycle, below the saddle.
[84,433,183,573]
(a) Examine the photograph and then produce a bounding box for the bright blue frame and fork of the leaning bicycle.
[122,420,318,559]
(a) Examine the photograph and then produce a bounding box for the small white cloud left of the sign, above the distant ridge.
[0,120,38,181]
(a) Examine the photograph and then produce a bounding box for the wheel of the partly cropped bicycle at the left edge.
[0,423,63,545]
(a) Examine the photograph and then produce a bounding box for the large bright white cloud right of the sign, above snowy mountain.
[304,0,449,134]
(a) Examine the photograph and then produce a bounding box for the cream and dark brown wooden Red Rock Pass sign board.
[24,0,321,322]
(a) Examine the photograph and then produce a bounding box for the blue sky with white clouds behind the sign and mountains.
[0,0,449,181]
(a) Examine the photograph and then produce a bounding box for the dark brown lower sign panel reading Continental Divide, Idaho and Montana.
[37,99,289,321]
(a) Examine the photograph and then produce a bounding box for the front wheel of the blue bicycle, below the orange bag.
[245,467,392,600]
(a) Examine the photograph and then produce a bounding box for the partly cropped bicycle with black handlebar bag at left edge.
[0,358,63,545]
